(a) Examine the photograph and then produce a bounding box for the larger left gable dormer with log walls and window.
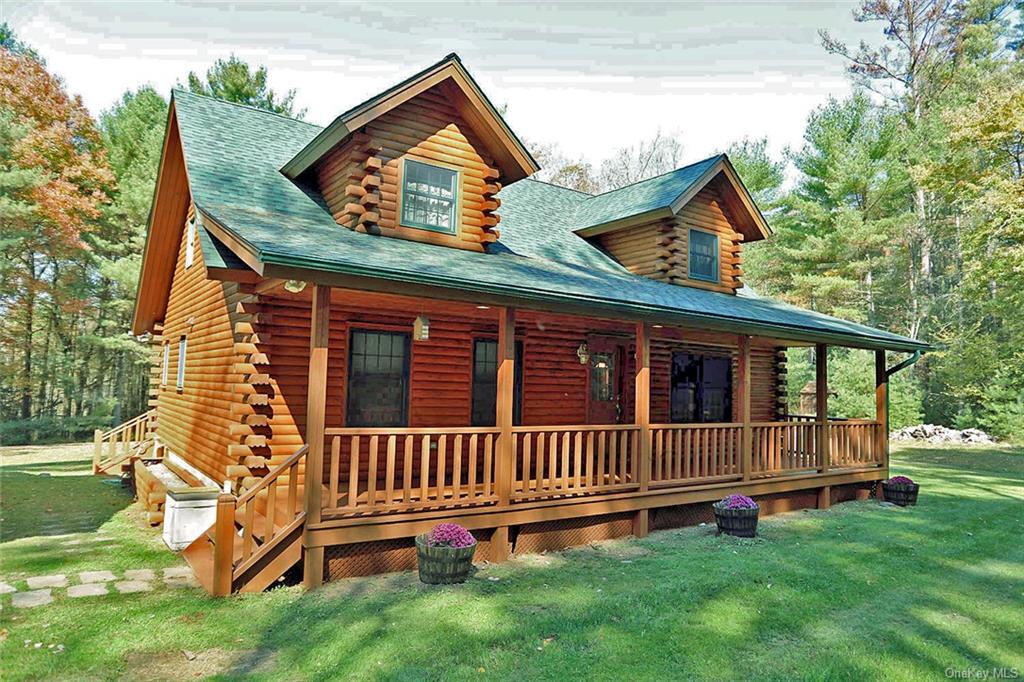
[282,54,538,251]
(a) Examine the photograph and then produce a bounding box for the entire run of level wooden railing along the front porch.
[323,418,884,516]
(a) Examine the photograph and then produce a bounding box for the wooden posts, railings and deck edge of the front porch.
[270,286,888,587]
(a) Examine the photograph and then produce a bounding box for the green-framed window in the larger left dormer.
[401,159,459,235]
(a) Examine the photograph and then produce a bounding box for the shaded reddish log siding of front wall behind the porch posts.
[255,296,775,471]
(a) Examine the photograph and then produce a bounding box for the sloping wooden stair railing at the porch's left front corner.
[213,445,309,595]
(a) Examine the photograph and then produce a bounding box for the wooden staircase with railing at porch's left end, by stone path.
[184,445,308,596]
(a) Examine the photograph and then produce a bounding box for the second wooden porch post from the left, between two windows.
[490,307,515,561]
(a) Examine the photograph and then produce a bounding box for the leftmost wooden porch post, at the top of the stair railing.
[302,285,331,589]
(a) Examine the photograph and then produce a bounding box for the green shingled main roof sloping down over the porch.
[173,90,925,350]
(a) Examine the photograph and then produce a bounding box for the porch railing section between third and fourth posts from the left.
[650,423,743,486]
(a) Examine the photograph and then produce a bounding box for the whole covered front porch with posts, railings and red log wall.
[268,285,888,586]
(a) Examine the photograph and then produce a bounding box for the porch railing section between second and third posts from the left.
[511,424,640,502]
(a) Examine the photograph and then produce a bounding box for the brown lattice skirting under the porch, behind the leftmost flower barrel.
[324,530,490,581]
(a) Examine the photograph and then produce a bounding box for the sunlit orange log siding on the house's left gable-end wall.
[156,206,241,480]
